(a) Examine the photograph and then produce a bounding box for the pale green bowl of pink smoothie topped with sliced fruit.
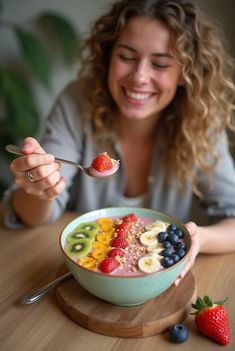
[60,207,191,306]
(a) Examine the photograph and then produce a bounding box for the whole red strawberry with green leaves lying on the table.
[192,296,231,345]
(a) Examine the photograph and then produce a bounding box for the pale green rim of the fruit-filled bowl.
[59,206,192,279]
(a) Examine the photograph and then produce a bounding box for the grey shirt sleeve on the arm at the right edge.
[198,133,235,221]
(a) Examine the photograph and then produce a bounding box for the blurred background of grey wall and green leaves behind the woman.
[0,0,235,198]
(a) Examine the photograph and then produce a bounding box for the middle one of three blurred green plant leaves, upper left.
[13,27,51,88]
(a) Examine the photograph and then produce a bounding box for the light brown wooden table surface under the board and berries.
[0,205,235,351]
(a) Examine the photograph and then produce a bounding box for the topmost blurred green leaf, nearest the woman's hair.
[37,12,80,64]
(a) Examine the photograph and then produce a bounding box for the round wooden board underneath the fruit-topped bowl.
[56,266,196,338]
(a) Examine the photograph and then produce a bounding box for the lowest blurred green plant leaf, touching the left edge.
[0,67,40,140]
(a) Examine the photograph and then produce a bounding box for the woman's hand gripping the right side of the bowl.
[174,222,200,286]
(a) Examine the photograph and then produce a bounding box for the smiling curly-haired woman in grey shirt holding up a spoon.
[4,0,235,285]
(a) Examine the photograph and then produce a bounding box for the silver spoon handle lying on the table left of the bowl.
[20,272,72,305]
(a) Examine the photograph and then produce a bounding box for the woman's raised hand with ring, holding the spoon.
[10,137,65,201]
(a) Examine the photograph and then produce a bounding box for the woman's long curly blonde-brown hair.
[79,0,235,193]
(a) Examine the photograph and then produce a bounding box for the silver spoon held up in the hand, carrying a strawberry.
[6,145,119,178]
